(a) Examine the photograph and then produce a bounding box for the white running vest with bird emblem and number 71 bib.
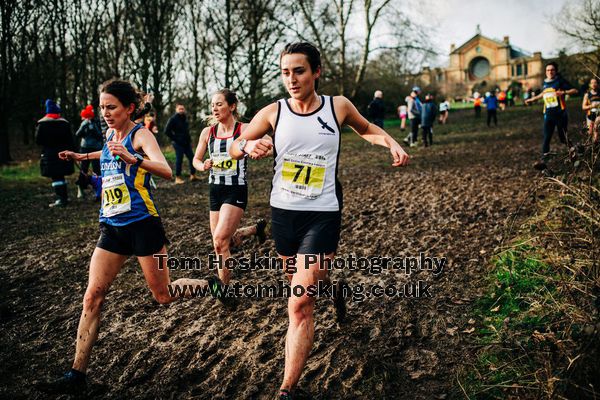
[271,96,342,211]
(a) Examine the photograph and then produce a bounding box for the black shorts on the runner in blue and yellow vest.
[96,217,169,257]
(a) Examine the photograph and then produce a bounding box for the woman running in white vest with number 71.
[229,43,408,400]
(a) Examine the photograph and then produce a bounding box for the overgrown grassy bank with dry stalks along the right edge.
[458,140,600,399]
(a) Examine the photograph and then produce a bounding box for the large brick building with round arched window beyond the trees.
[420,28,544,96]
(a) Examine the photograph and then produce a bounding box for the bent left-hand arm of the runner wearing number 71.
[229,103,277,160]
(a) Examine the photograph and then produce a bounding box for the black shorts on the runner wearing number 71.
[271,207,342,257]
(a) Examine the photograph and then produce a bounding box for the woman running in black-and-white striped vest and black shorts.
[194,89,266,284]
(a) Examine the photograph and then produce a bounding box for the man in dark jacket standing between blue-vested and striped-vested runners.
[165,104,196,183]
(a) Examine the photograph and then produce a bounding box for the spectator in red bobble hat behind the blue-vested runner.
[75,104,104,199]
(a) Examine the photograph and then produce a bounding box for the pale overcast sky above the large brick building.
[413,0,567,66]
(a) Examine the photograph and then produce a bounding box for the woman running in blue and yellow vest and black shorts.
[38,80,207,393]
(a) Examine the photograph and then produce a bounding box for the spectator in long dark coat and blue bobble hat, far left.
[35,99,75,207]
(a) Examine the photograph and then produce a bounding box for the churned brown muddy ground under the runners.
[0,102,580,399]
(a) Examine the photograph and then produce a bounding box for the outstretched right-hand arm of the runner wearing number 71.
[333,96,408,167]
